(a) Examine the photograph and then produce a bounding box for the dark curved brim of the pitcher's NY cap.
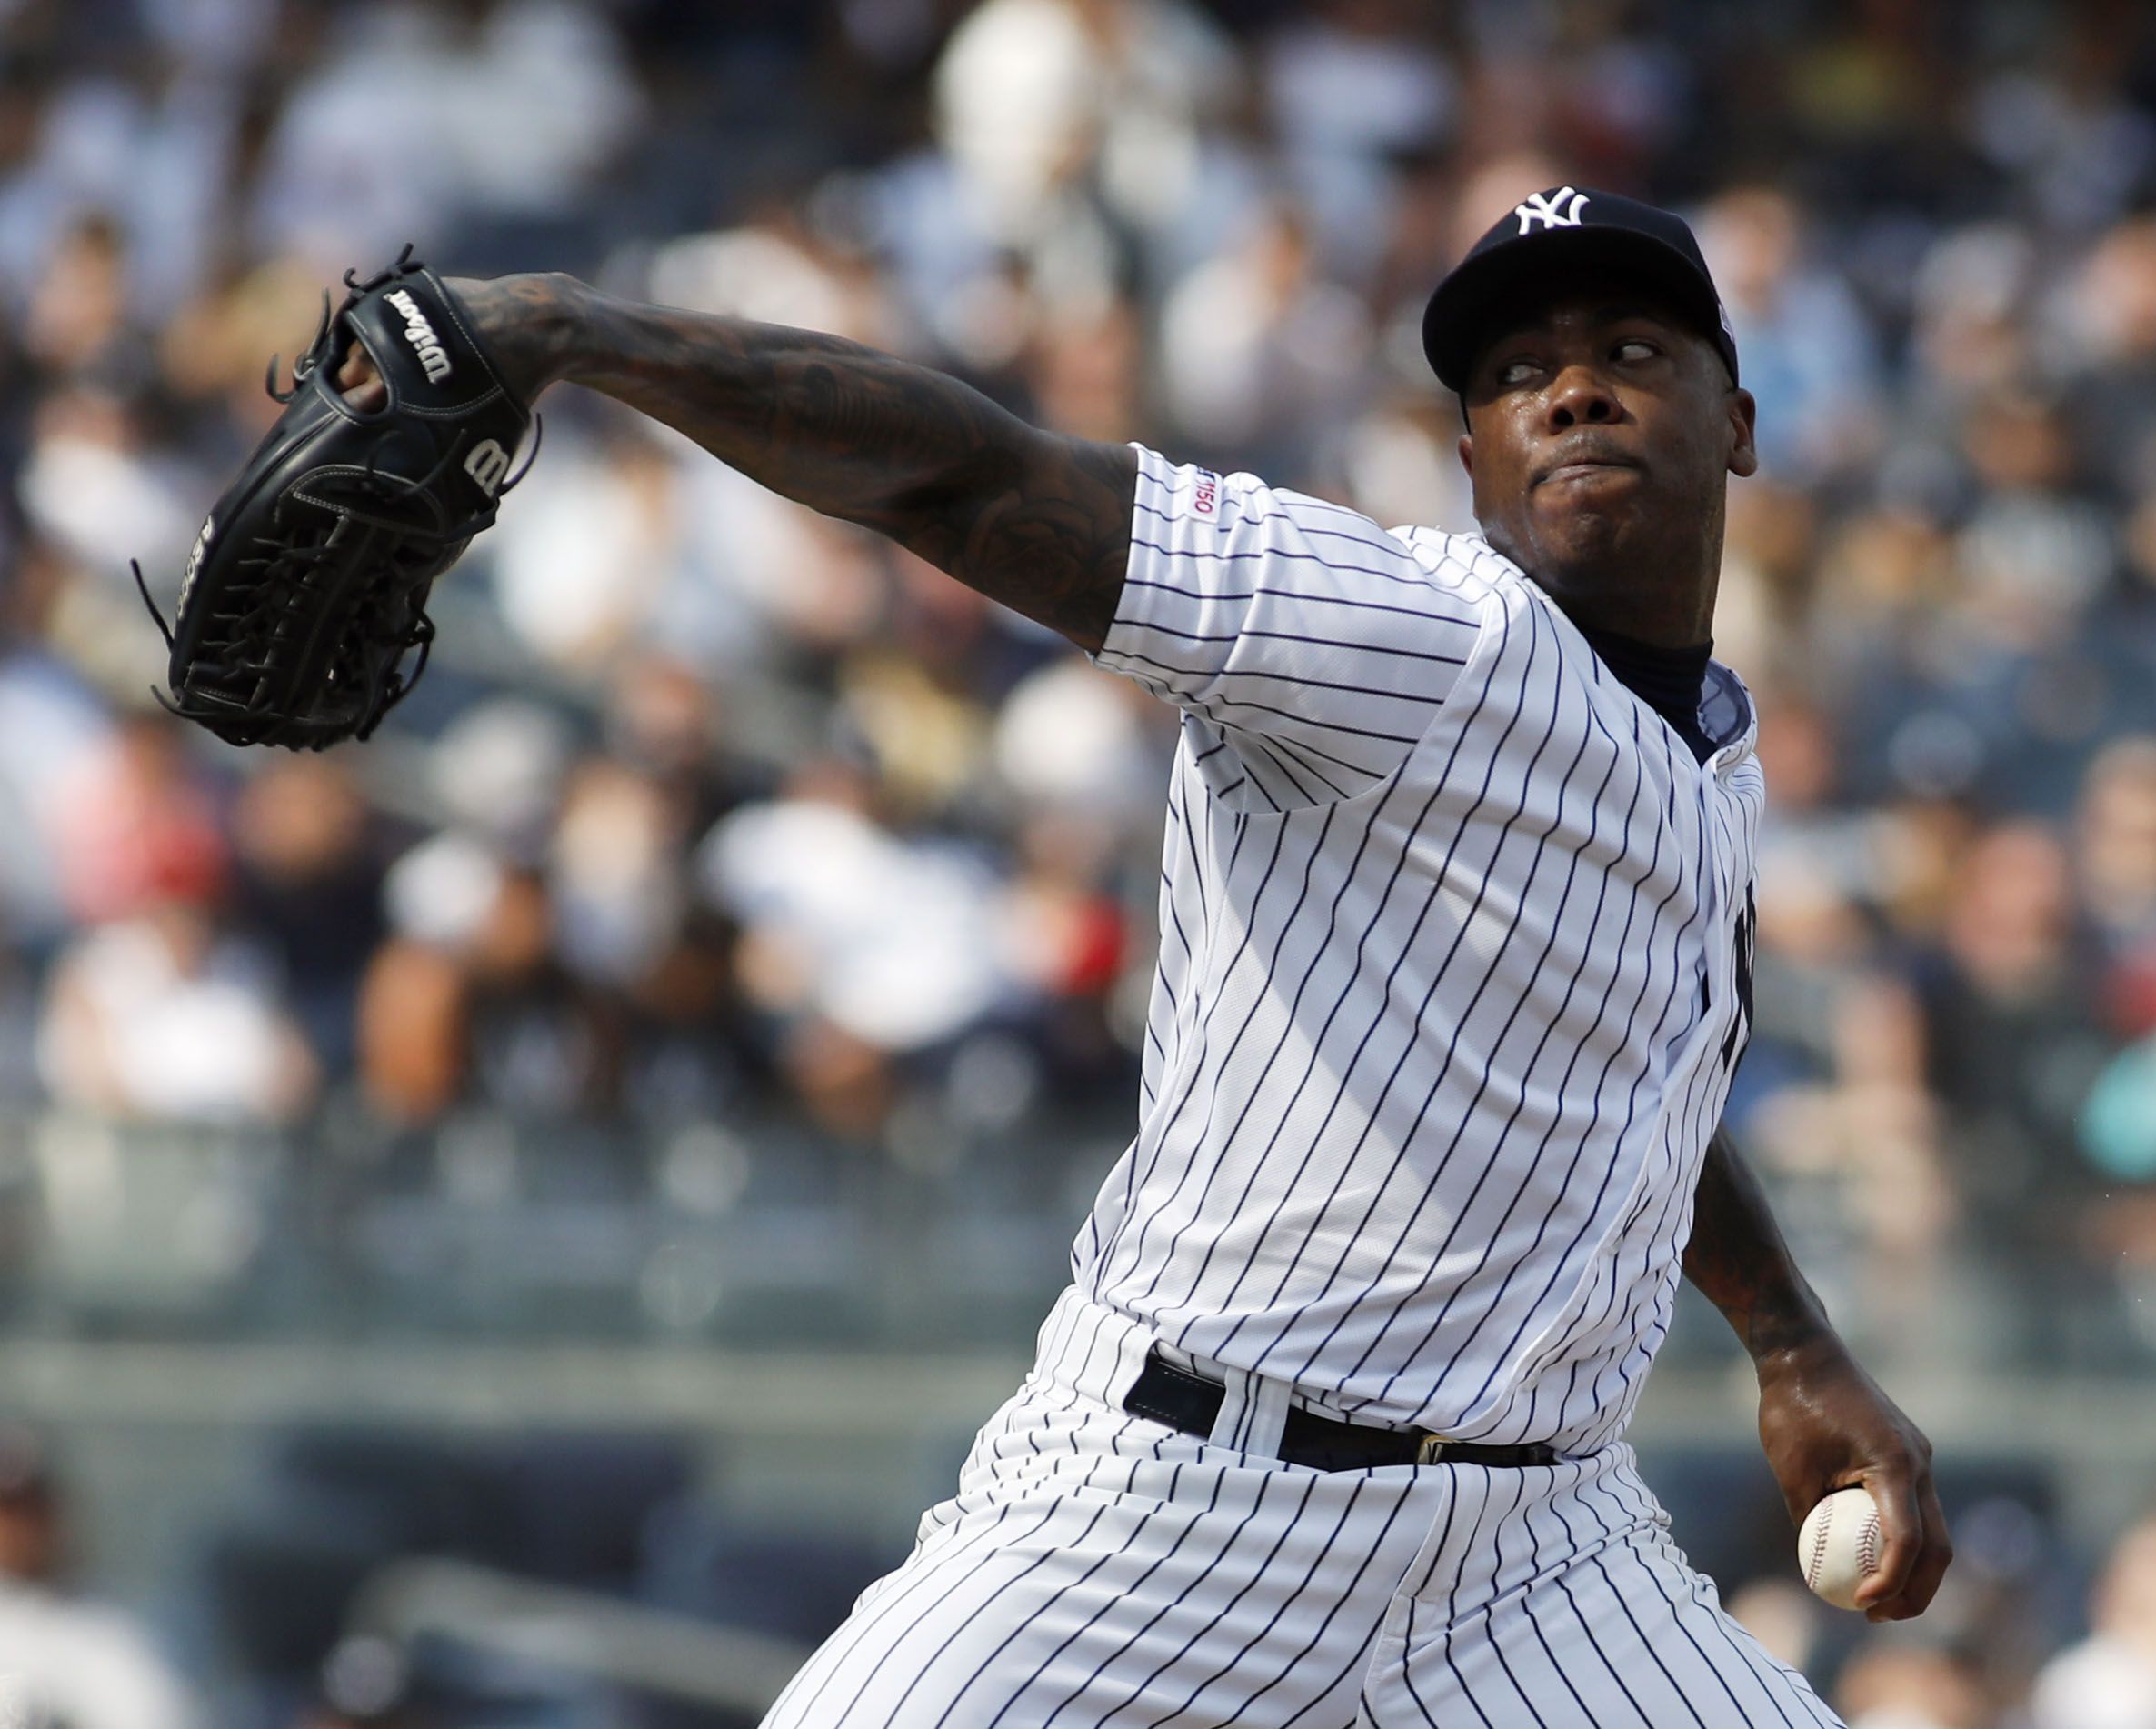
[1423,226,1735,395]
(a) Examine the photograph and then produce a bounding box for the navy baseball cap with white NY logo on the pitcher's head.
[1423,185,1738,393]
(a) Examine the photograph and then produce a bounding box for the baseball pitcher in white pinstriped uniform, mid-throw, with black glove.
[155,185,1951,1729]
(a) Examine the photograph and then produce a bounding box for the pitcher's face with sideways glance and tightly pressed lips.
[1460,286,1757,634]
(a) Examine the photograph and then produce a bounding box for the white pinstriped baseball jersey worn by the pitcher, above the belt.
[1073,451,1763,1453]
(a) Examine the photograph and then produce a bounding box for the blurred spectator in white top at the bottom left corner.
[0,1425,196,1729]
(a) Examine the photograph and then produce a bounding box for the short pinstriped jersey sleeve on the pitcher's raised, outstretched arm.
[1095,446,1482,811]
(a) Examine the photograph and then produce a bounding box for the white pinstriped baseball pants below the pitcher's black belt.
[765,1294,1837,1729]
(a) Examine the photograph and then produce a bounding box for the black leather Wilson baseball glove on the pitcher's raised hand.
[135,245,533,750]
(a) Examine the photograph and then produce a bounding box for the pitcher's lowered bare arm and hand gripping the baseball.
[1684,1127,1953,1621]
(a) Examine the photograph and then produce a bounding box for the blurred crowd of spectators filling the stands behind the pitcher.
[0,0,2156,1729]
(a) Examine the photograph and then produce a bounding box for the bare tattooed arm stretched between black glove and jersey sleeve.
[470,276,1136,649]
